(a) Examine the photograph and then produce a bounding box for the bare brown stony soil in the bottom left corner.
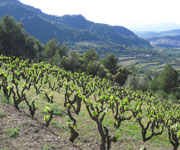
[0,102,80,150]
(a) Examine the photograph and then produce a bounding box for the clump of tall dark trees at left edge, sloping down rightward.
[0,15,43,58]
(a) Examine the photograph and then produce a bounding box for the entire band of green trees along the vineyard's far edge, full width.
[0,15,180,99]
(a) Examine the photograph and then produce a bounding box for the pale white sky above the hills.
[20,0,180,27]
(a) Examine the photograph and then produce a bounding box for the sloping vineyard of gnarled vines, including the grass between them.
[0,56,180,150]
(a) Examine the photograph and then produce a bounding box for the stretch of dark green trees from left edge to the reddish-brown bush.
[0,15,130,84]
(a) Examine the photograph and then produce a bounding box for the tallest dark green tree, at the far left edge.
[0,15,27,56]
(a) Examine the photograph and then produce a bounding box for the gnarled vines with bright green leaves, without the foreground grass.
[0,56,180,150]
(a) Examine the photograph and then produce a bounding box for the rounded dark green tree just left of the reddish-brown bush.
[102,54,118,74]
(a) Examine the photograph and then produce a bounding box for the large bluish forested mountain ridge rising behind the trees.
[0,0,151,56]
